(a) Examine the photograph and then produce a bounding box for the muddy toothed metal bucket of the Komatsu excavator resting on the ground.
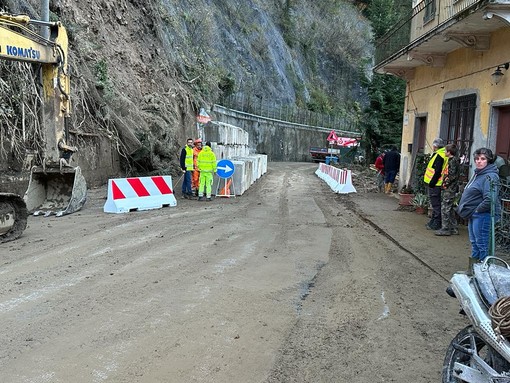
[24,166,87,217]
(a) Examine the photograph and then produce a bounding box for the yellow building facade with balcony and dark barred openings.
[375,0,510,186]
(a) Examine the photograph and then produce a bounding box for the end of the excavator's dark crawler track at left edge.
[0,193,28,243]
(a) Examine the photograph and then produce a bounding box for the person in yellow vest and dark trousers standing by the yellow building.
[423,138,448,230]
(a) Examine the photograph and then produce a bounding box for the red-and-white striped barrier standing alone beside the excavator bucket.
[103,176,177,213]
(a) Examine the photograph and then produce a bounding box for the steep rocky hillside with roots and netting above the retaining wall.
[0,0,372,177]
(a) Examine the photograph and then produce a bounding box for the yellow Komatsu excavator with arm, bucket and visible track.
[0,12,87,243]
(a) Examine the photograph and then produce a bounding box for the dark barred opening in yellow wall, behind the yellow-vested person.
[441,94,476,181]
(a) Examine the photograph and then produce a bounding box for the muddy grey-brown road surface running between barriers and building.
[0,163,469,383]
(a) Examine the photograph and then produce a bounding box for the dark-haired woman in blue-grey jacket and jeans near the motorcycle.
[457,148,501,263]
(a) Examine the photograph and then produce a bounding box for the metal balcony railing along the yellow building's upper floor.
[375,0,487,66]
